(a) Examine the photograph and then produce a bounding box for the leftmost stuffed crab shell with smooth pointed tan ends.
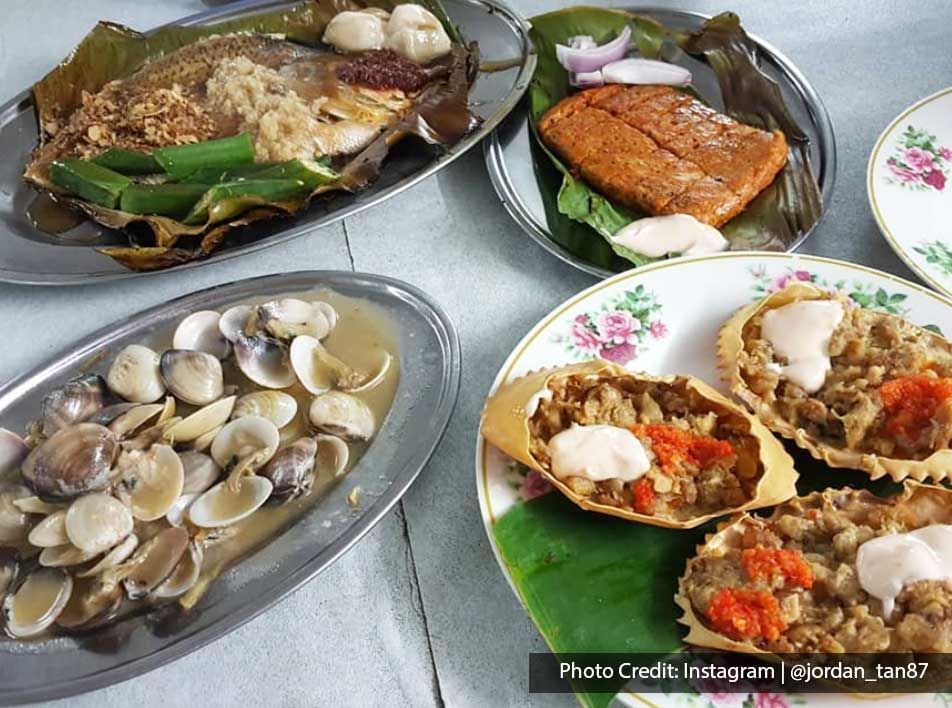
[482,361,797,528]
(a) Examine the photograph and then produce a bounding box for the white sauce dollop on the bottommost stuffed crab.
[856,524,952,619]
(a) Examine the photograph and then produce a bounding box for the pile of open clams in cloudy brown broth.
[0,291,399,640]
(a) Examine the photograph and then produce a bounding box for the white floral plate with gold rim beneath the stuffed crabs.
[476,253,952,708]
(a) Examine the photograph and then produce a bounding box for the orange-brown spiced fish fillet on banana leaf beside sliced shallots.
[539,84,787,226]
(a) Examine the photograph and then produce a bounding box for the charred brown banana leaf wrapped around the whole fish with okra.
[24,0,478,270]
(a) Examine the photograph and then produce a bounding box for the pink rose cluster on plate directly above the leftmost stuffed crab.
[554,285,668,365]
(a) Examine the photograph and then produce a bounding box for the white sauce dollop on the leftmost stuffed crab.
[549,425,651,482]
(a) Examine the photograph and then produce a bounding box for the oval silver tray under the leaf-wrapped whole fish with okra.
[0,0,535,285]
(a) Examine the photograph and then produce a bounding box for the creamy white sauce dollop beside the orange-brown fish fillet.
[612,214,727,258]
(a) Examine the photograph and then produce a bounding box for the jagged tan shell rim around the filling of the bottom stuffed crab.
[674,480,952,660]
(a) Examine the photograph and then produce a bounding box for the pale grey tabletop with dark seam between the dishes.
[0,0,952,708]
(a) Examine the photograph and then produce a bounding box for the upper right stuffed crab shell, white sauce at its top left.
[718,283,952,481]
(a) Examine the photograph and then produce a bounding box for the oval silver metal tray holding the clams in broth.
[0,271,460,705]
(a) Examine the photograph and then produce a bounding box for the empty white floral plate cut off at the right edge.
[866,88,952,295]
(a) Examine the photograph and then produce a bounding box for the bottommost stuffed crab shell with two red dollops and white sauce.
[675,481,952,654]
